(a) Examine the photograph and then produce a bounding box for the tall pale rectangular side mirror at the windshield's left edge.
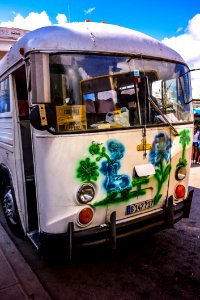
[30,53,51,104]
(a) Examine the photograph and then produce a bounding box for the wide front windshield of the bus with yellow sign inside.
[46,54,192,132]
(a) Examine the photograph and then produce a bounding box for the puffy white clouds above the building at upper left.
[0,11,67,30]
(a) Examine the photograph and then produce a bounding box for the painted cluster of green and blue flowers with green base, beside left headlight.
[77,140,149,206]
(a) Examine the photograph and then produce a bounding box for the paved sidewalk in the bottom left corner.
[0,224,51,300]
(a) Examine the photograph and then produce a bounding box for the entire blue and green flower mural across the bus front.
[76,129,191,206]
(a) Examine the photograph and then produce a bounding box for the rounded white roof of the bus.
[0,22,185,74]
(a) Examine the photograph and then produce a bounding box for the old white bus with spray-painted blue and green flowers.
[0,22,194,257]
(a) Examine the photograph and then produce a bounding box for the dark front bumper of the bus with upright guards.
[39,190,193,253]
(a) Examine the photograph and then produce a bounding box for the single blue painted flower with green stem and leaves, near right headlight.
[149,133,172,205]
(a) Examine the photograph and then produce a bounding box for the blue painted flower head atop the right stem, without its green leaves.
[149,133,172,167]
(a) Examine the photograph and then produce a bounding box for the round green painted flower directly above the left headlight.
[77,157,99,181]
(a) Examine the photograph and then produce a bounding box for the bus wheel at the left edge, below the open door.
[2,185,23,236]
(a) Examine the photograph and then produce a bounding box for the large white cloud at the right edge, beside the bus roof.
[162,14,200,68]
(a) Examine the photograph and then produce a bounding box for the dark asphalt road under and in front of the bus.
[0,166,200,300]
